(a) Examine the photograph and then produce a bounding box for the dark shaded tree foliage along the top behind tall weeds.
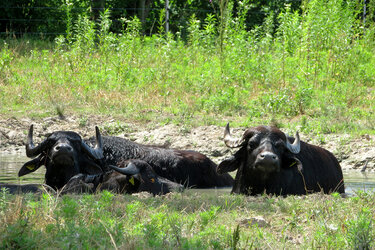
[0,0,302,38]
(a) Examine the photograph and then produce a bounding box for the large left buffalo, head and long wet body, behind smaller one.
[19,126,233,192]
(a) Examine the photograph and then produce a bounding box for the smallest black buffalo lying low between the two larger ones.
[62,160,184,195]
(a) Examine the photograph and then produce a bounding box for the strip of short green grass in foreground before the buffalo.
[0,190,375,249]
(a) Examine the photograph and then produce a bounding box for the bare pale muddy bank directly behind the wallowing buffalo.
[0,115,375,171]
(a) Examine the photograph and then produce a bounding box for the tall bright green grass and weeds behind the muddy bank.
[0,0,375,133]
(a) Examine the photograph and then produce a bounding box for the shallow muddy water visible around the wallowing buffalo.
[0,153,375,194]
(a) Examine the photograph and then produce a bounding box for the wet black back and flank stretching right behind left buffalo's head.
[84,136,233,188]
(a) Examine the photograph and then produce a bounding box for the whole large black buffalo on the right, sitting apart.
[217,124,345,195]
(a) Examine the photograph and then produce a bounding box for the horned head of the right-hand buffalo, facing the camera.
[217,124,302,187]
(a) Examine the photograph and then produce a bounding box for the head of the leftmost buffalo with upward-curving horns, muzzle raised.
[18,125,103,189]
